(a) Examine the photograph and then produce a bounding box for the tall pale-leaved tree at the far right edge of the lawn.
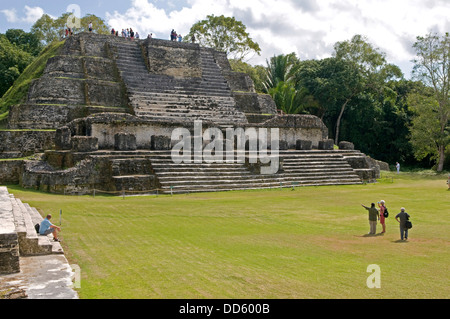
[410,33,450,172]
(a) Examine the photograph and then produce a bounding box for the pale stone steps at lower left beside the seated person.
[9,190,64,256]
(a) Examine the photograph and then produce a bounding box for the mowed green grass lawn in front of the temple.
[4,174,450,299]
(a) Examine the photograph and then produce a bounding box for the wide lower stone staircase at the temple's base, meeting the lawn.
[144,151,362,193]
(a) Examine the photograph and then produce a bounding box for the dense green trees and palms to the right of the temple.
[232,35,450,171]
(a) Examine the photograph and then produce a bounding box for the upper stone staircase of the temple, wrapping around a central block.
[112,41,247,125]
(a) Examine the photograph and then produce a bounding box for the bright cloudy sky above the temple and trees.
[0,0,450,78]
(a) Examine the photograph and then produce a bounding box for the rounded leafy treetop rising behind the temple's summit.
[185,15,261,60]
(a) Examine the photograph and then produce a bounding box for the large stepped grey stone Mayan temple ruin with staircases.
[0,33,379,194]
